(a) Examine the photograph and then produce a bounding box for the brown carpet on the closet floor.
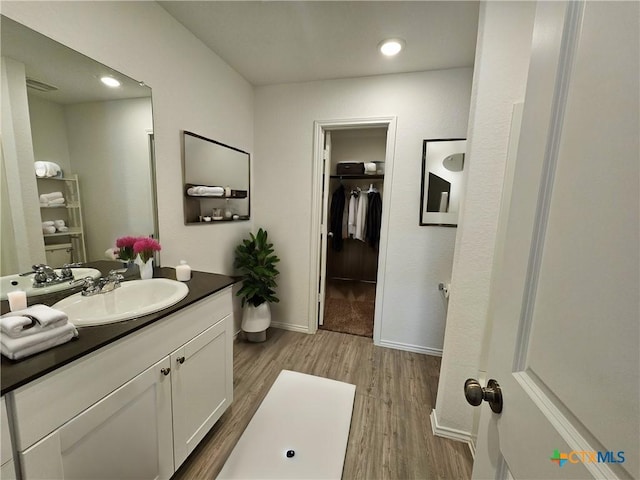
[320,279,376,338]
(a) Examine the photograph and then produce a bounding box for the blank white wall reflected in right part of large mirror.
[64,97,154,260]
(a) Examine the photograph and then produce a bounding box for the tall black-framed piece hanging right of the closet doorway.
[420,138,467,227]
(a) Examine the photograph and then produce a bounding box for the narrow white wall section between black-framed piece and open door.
[432,2,535,439]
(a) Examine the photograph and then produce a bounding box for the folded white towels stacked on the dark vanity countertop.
[0,305,78,360]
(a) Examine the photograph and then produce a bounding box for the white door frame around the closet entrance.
[308,116,397,345]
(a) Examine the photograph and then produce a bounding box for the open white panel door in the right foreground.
[474,2,640,479]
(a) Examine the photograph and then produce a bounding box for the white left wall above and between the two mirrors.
[2,1,253,282]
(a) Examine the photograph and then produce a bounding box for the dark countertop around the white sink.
[0,260,238,395]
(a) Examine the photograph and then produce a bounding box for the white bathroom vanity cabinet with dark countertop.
[2,262,235,479]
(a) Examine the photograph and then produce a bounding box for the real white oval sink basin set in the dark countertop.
[53,278,189,327]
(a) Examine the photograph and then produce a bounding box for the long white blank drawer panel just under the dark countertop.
[8,287,232,451]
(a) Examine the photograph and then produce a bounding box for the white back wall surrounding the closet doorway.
[252,68,472,352]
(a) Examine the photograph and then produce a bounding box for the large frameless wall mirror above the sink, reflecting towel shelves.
[0,16,158,275]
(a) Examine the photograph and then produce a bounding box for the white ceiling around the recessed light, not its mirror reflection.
[158,0,479,86]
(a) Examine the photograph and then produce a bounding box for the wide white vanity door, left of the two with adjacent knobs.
[20,357,174,480]
